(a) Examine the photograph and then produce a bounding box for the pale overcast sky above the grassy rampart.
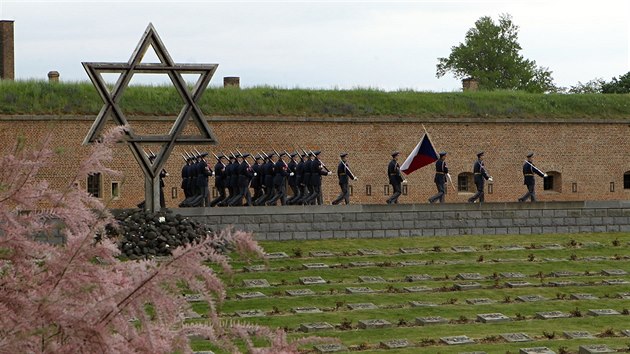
[0,0,630,92]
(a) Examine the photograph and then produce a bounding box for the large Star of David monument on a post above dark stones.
[82,23,218,211]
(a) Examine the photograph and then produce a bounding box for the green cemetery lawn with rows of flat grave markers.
[189,233,630,353]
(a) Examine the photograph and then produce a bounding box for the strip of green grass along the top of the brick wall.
[0,81,630,119]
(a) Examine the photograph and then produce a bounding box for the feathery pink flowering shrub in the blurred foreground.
[0,129,326,353]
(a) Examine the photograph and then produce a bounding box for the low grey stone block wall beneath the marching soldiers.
[173,201,630,240]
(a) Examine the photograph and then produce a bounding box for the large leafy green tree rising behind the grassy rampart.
[436,14,556,92]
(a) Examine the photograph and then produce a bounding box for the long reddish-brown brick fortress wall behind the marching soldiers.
[0,116,630,208]
